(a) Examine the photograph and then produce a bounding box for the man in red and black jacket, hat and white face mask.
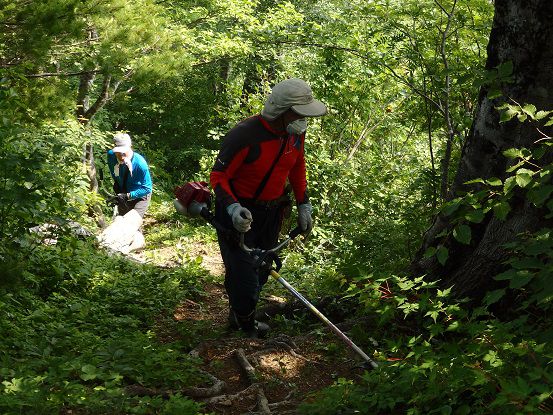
[210,78,326,337]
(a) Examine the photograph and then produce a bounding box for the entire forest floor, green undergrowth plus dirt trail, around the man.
[0,188,552,415]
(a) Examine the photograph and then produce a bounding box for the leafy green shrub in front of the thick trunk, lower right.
[302,124,553,415]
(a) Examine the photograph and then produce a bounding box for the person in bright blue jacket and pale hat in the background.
[108,133,152,217]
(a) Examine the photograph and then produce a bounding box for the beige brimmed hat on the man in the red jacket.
[261,78,327,121]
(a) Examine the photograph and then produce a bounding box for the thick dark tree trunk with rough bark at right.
[412,0,553,298]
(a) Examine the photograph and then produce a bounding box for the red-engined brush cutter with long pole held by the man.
[174,182,378,369]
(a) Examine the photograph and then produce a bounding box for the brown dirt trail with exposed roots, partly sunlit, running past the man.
[134,224,363,415]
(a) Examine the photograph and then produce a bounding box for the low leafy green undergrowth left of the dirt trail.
[0,237,207,414]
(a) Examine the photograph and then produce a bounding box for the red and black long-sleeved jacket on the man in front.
[210,115,308,207]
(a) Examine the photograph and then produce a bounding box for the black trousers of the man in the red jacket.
[215,202,282,316]
